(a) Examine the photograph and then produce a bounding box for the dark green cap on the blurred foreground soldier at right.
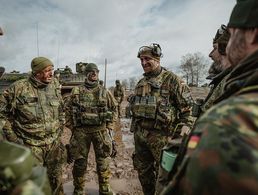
[228,0,258,28]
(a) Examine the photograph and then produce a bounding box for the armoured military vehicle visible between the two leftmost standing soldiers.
[56,62,87,98]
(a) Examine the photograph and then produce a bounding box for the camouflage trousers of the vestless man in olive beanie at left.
[26,141,66,195]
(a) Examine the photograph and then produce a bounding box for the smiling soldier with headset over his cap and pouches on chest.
[130,43,192,195]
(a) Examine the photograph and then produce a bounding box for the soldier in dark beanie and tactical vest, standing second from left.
[65,63,117,195]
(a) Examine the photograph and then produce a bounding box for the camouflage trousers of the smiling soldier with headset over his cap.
[133,128,167,195]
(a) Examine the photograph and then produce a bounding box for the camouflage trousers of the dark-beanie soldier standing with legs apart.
[70,130,112,195]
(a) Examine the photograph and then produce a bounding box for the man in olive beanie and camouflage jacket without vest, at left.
[0,57,66,194]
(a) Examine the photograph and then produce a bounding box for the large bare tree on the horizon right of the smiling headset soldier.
[180,52,208,86]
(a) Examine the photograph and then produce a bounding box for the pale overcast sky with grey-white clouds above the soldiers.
[0,0,236,86]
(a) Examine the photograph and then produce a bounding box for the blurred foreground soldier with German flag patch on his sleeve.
[162,0,258,195]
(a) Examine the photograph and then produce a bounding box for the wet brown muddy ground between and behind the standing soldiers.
[63,88,209,195]
